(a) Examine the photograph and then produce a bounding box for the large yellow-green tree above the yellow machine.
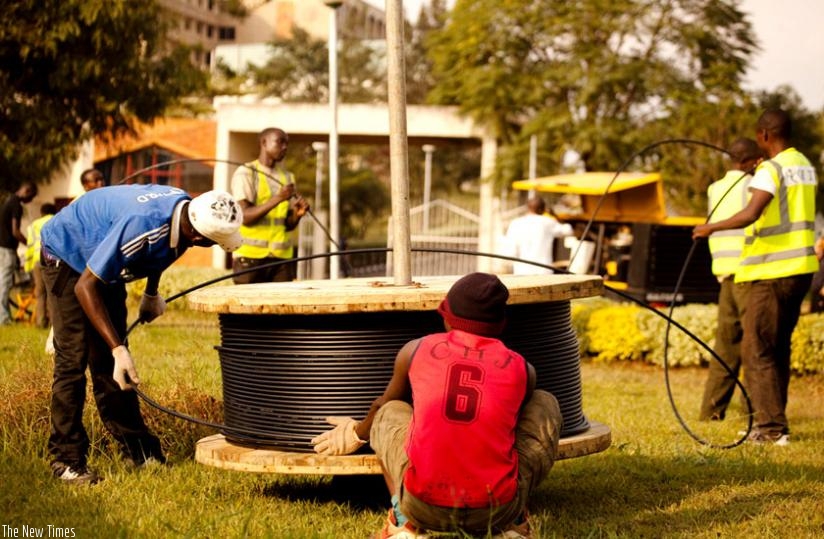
[429,0,757,205]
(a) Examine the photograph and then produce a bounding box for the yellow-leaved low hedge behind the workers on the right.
[572,298,824,374]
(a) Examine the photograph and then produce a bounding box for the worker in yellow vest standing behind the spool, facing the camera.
[232,127,309,284]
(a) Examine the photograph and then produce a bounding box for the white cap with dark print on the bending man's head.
[189,190,243,252]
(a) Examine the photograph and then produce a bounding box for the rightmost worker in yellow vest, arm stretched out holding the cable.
[693,109,818,445]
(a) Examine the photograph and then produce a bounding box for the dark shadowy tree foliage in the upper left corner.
[0,0,206,189]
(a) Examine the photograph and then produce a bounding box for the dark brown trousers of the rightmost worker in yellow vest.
[741,274,812,437]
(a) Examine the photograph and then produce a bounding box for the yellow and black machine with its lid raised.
[512,172,718,303]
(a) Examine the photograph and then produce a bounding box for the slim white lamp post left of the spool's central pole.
[324,0,343,279]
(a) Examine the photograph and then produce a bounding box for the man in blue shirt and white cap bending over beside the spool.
[40,185,243,483]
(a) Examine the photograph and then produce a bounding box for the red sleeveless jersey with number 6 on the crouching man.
[404,330,527,508]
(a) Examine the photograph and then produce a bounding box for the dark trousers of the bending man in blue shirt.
[42,262,164,465]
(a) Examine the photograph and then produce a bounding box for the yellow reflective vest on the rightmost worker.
[735,148,818,282]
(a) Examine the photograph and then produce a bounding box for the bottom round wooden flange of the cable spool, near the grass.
[195,421,612,475]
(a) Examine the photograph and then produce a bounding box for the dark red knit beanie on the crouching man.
[438,273,509,337]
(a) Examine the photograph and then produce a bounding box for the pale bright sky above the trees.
[367,0,824,112]
